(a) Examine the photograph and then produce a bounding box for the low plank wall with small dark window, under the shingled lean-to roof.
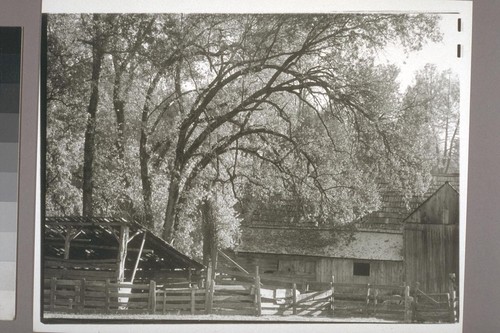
[234,253,404,285]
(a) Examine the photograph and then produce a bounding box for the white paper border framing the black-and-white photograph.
[33,0,472,333]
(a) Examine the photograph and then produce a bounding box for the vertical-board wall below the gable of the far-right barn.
[404,224,459,293]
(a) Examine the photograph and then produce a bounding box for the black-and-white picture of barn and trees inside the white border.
[39,1,470,327]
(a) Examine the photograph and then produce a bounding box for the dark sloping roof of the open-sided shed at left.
[44,216,204,269]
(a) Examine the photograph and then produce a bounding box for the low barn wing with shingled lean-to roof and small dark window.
[235,227,404,284]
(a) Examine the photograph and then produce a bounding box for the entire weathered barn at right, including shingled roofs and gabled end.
[229,174,459,292]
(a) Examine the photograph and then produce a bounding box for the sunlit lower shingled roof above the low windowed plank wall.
[235,227,403,261]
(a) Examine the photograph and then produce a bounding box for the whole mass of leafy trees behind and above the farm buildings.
[42,14,450,256]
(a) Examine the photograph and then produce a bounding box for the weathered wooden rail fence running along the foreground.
[44,267,458,322]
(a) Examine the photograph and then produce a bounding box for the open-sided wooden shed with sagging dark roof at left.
[43,216,203,285]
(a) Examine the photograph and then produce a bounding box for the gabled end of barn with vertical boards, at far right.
[404,182,459,293]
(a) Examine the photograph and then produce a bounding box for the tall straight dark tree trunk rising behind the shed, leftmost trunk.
[82,14,104,216]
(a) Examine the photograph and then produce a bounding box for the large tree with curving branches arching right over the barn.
[163,15,438,240]
